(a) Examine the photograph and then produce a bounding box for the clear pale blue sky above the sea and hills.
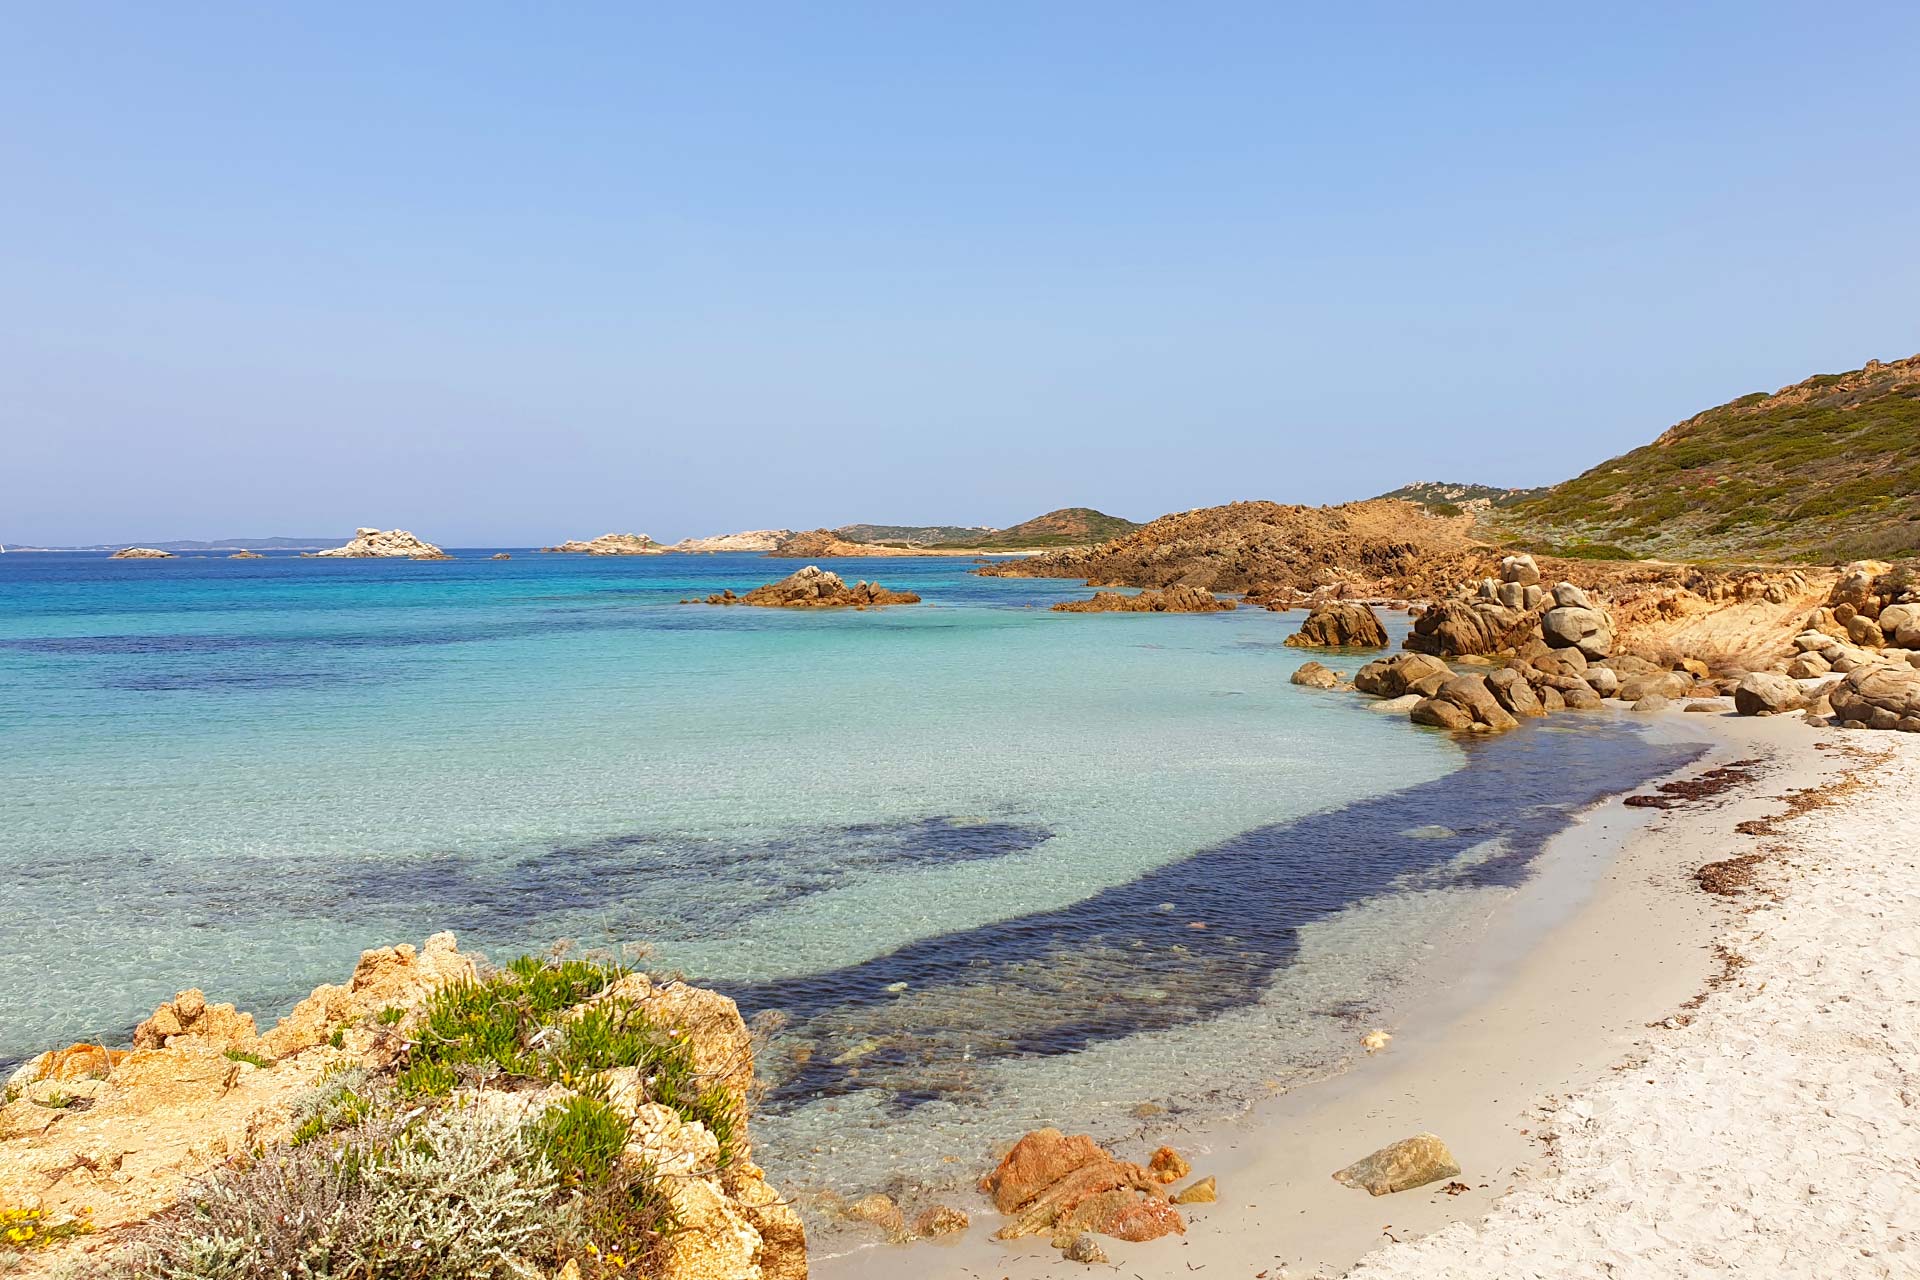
[0,2,1920,545]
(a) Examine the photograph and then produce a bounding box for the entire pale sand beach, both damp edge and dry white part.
[816,718,1920,1280]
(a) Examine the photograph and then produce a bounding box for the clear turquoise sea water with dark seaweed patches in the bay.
[0,551,1676,1212]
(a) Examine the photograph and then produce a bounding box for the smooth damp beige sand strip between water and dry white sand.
[814,716,1849,1280]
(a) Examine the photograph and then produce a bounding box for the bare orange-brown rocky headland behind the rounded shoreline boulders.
[979,499,1492,601]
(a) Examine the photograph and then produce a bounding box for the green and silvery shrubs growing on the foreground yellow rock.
[60,958,741,1280]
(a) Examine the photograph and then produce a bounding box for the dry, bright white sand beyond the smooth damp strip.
[1351,733,1920,1280]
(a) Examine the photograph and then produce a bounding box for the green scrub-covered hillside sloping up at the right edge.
[1461,355,1920,562]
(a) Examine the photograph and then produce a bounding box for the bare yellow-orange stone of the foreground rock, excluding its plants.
[0,935,806,1280]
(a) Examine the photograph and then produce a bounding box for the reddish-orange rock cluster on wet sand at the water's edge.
[979,1128,1187,1249]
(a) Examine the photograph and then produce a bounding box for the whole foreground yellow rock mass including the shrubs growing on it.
[0,935,806,1280]
